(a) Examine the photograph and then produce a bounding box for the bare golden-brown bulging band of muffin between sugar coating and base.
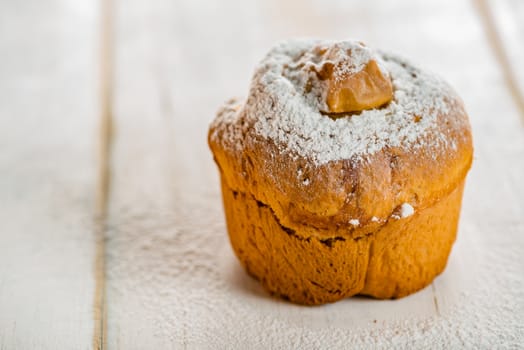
[209,99,473,238]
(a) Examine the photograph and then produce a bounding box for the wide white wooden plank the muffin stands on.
[107,0,524,349]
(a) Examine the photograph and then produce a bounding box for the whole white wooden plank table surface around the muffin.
[0,0,524,350]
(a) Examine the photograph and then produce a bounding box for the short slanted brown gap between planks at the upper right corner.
[473,0,524,126]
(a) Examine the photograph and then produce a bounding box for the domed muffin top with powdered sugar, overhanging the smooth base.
[209,40,472,239]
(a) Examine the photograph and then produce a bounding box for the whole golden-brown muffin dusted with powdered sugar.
[208,40,473,305]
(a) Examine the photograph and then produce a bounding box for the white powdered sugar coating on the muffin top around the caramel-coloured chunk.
[214,40,453,165]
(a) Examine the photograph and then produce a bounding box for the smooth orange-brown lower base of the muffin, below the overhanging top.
[222,181,464,305]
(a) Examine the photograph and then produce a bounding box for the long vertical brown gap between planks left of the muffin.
[92,0,113,350]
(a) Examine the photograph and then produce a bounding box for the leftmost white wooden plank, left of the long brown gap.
[0,1,102,349]
